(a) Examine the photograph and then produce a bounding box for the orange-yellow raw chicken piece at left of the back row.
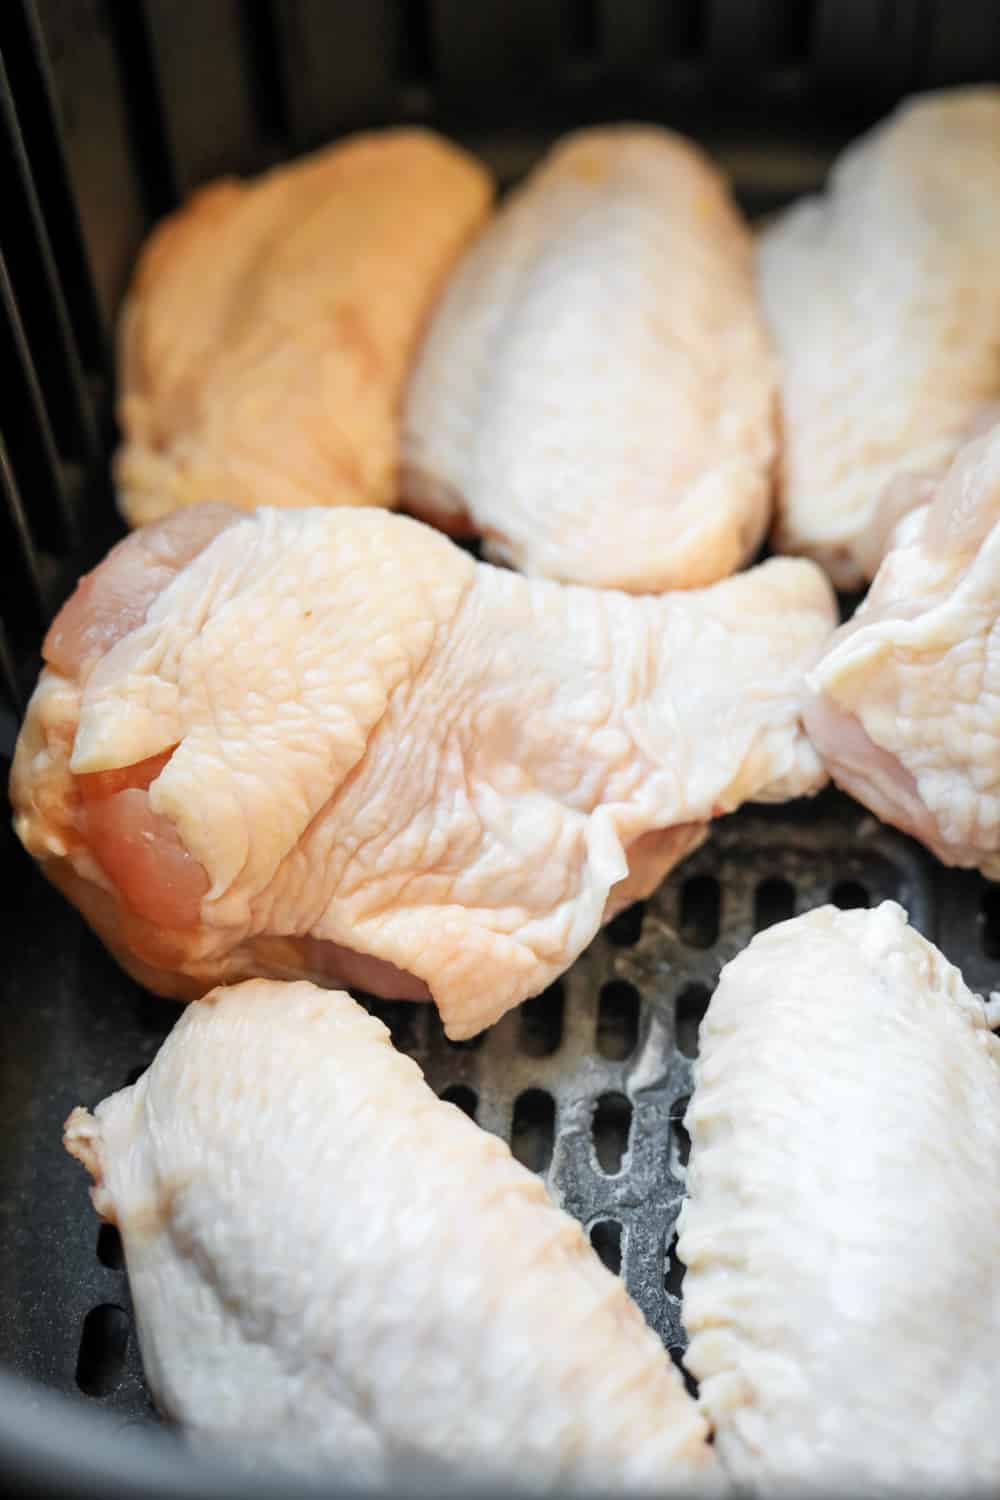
[115,129,492,525]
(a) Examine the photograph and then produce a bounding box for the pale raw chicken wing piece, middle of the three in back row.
[403,128,777,593]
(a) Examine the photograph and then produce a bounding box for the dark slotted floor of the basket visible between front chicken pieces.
[0,792,1000,1424]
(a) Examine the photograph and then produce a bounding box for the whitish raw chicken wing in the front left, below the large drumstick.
[66,980,715,1494]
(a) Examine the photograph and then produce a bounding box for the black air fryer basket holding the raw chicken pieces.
[0,0,1000,1496]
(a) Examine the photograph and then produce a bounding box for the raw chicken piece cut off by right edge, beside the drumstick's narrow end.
[805,425,1000,879]
